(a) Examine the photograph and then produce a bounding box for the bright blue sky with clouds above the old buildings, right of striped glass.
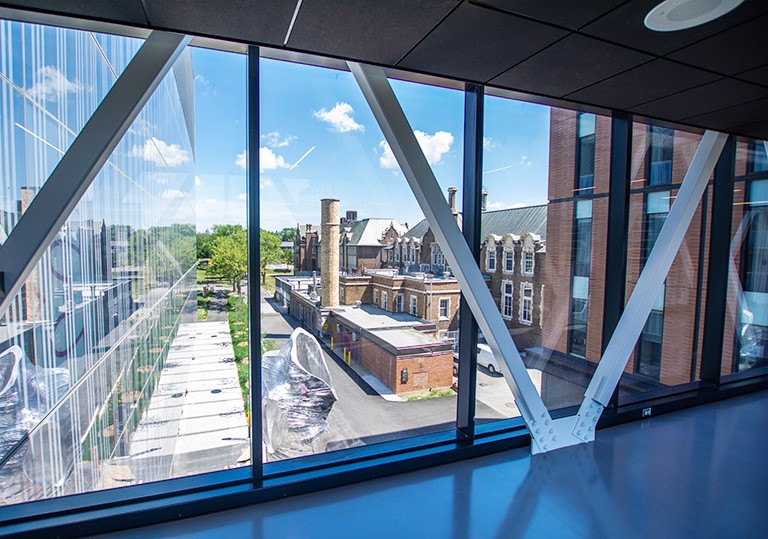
[193,49,549,230]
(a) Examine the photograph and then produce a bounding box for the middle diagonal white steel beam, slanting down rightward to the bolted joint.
[349,62,560,453]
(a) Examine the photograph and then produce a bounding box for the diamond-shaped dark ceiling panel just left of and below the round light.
[490,34,653,97]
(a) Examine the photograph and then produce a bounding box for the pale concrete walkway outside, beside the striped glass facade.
[130,322,249,481]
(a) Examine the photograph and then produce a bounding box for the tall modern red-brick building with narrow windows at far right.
[540,108,768,404]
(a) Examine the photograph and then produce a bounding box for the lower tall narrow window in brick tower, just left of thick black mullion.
[568,200,592,357]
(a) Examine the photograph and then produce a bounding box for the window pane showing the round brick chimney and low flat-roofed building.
[260,59,464,461]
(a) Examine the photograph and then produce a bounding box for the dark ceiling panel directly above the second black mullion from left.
[398,4,567,82]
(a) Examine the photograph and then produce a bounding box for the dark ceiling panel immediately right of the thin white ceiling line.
[288,0,460,64]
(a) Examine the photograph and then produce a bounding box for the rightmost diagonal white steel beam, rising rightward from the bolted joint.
[573,131,728,441]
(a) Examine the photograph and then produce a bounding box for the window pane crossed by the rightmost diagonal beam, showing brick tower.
[619,123,712,399]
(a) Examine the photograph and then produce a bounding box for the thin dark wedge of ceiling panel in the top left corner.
[3,0,147,25]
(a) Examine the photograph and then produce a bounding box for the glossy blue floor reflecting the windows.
[100,391,768,539]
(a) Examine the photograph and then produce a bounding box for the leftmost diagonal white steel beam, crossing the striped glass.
[0,31,191,317]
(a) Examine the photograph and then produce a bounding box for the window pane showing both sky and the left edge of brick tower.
[477,96,610,420]
